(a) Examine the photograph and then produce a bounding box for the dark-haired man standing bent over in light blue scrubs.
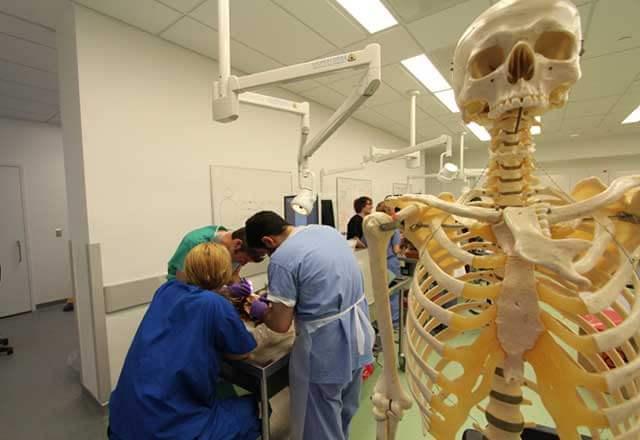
[245,211,374,440]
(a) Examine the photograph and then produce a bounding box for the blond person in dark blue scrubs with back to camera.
[109,242,260,440]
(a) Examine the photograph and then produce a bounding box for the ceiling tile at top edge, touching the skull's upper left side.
[408,0,491,52]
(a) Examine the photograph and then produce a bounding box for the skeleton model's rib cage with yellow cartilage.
[398,189,640,440]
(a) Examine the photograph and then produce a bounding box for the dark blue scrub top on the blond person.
[109,280,256,440]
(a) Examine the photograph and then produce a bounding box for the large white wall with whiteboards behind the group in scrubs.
[63,5,421,394]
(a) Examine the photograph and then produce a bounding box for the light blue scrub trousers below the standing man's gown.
[304,368,363,440]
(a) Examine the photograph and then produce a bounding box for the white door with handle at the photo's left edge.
[0,166,31,318]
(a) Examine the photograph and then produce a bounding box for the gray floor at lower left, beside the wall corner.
[0,305,107,440]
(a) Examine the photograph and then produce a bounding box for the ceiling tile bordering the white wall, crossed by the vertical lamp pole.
[161,17,281,73]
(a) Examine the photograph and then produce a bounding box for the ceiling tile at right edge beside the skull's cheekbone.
[569,48,640,101]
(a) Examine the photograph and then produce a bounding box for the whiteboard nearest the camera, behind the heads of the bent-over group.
[210,165,293,229]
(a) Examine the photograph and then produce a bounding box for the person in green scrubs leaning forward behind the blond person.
[167,225,265,282]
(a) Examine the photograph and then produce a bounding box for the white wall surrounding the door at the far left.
[0,119,73,304]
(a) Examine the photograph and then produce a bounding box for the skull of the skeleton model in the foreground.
[453,0,582,125]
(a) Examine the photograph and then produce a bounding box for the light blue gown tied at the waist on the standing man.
[268,225,373,384]
